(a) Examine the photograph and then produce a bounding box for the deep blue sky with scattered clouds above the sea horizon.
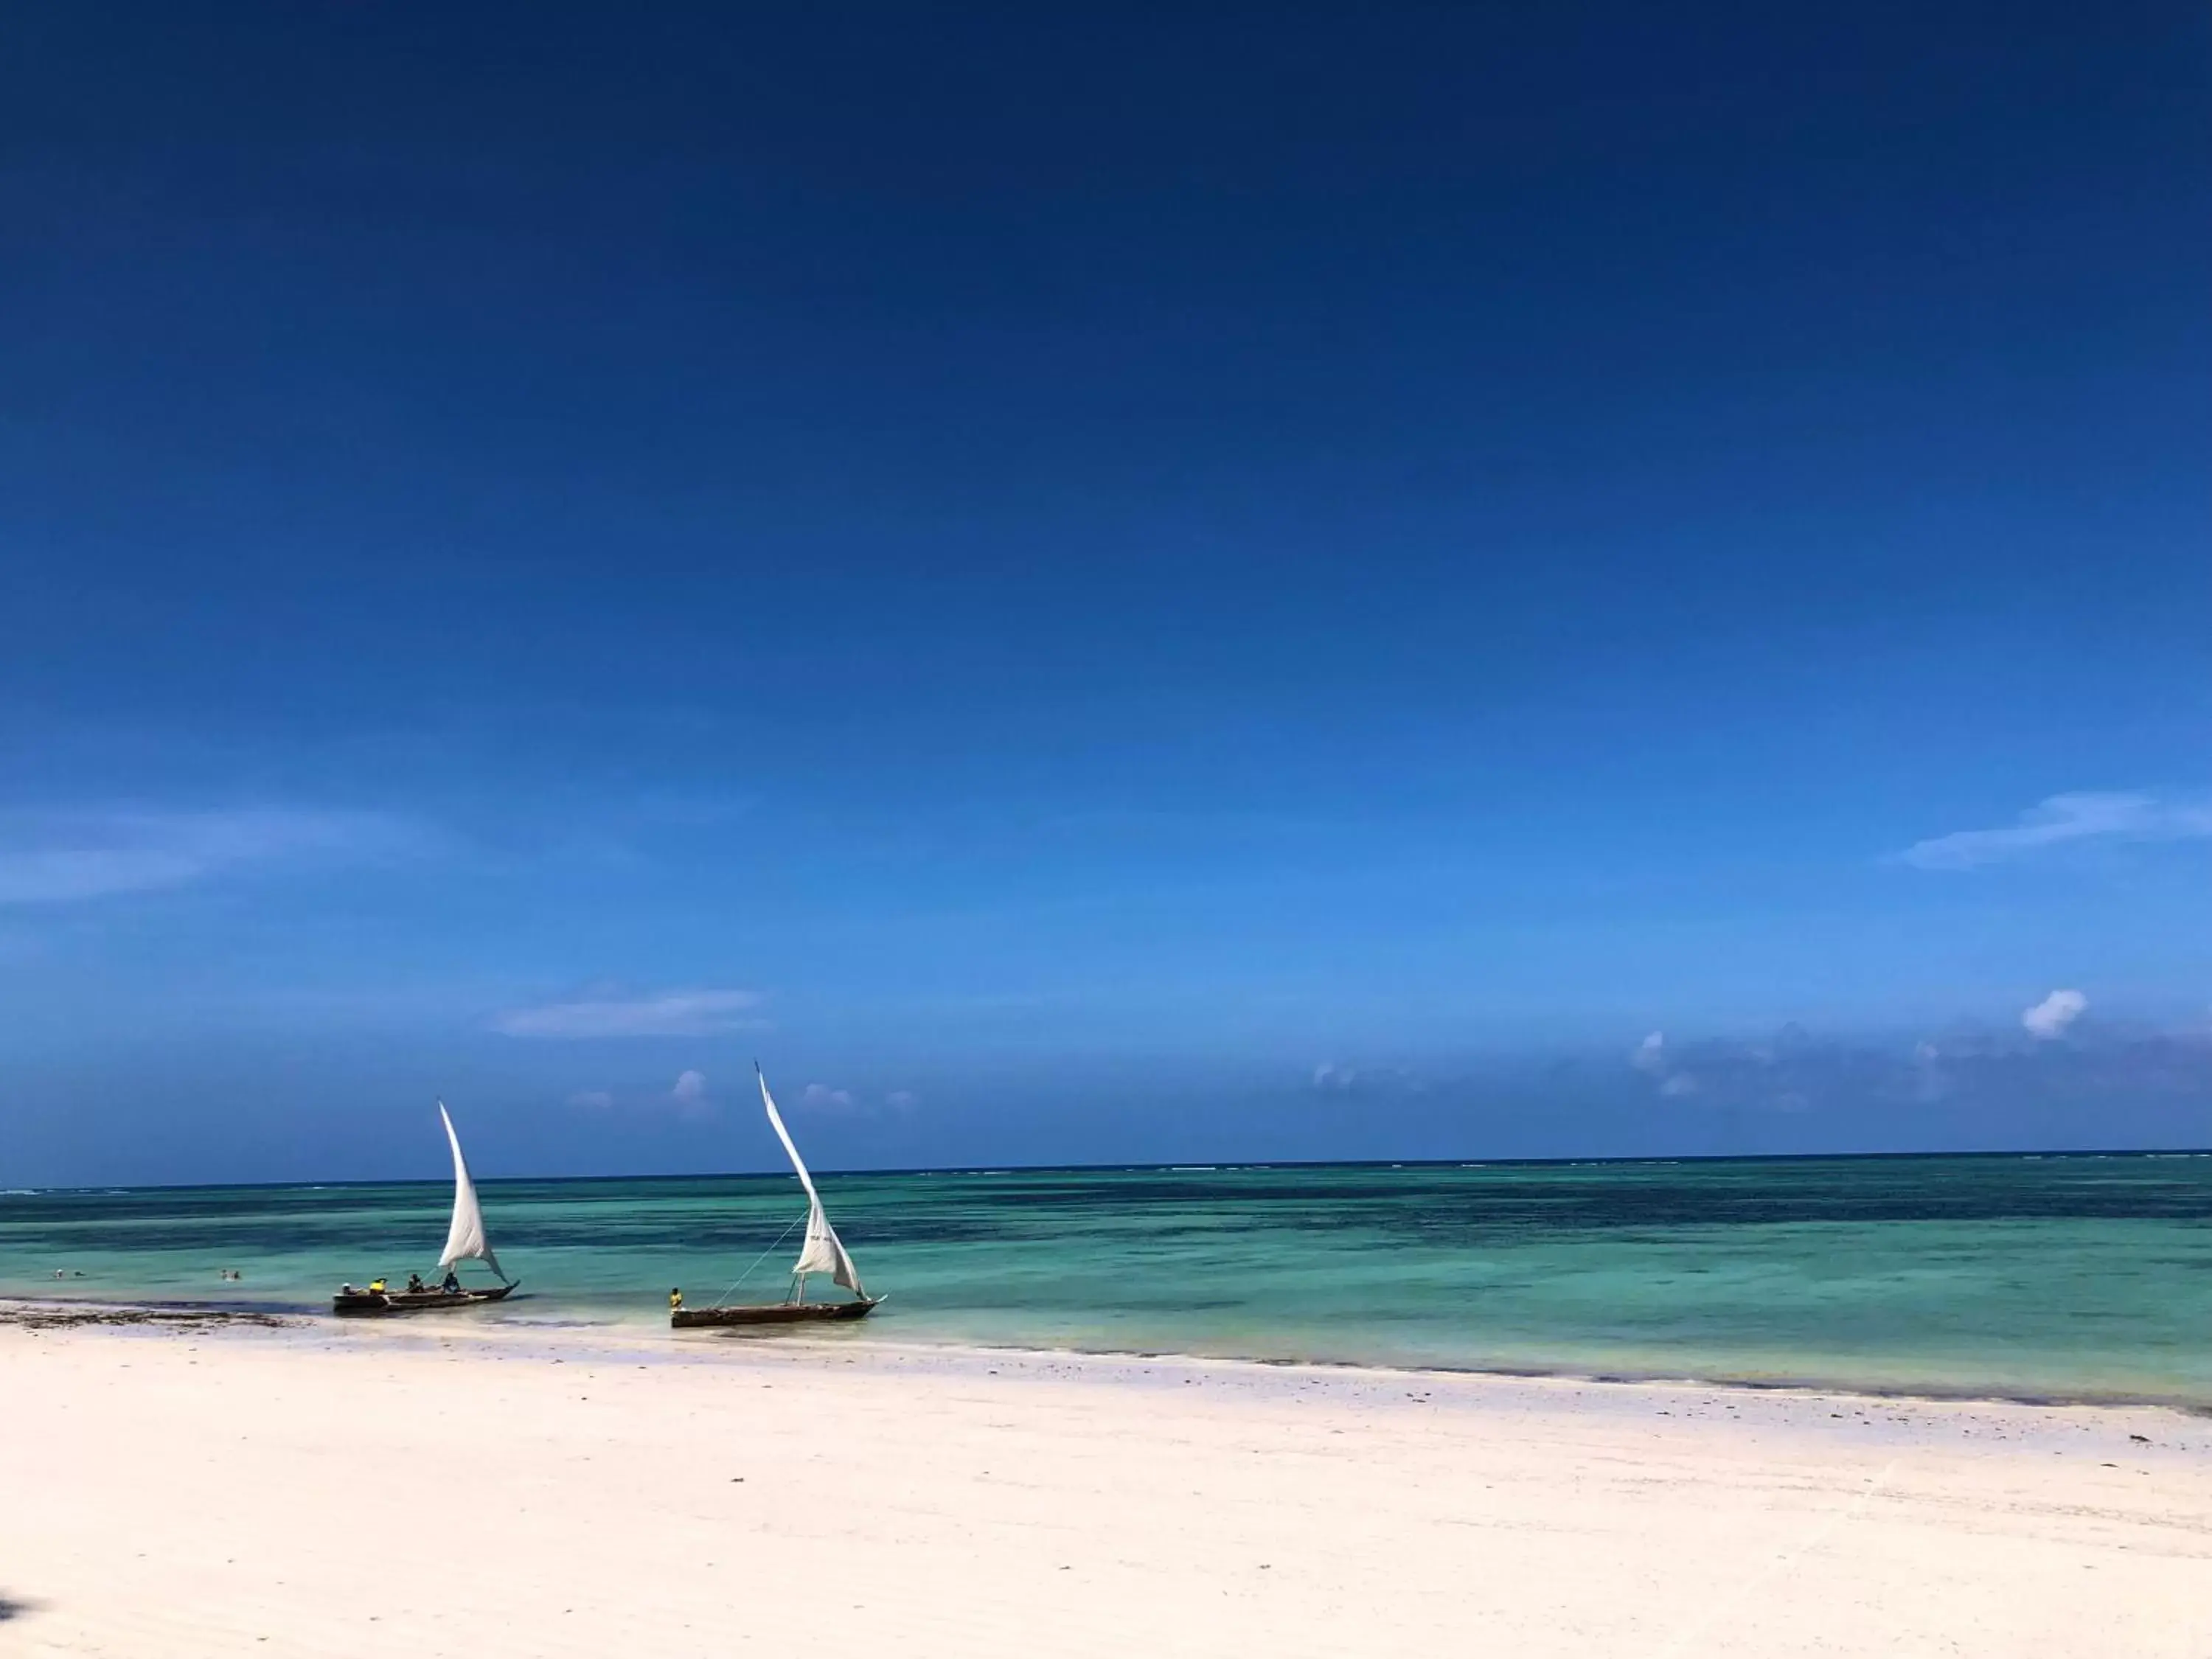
[0,4,2212,1183]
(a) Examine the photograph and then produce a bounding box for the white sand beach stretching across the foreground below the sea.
[0,1325,2212,1659]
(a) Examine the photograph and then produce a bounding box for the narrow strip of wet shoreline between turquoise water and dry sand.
[0,1296,2212,1422]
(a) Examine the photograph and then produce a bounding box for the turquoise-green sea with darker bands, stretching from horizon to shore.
[0,1155,2212,1409]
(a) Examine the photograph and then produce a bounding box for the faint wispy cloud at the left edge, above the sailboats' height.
[0,807,429,905]
